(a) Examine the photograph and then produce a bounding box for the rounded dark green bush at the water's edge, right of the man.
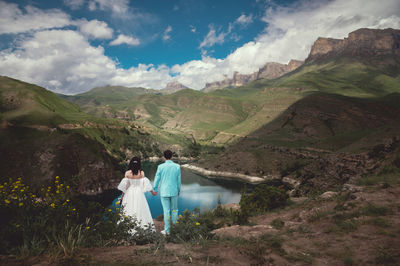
[239,184,289,214]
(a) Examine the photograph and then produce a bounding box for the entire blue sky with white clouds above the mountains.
[0,0,400,95]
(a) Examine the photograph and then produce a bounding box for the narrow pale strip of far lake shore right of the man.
[181,164,276,184]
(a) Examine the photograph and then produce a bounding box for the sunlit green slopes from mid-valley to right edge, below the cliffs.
[61,57,400,150]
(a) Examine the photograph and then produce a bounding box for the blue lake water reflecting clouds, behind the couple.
[143,163,244,218]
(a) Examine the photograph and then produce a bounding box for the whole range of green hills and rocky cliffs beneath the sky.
[0,29,400,194]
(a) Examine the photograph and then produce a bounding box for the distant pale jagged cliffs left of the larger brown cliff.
[203,60,303,92]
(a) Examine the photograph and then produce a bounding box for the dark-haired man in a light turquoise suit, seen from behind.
[153,150,181,235]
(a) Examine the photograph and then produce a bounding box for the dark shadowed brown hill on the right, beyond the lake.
[201,92,400,194]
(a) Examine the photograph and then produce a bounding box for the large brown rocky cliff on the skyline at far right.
[306,29,400,62]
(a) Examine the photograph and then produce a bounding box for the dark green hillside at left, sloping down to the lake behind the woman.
[0,77,160,192]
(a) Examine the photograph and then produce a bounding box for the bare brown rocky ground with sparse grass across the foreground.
[0,183,400,265]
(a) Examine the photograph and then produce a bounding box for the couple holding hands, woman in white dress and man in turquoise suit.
[118,150,181,234]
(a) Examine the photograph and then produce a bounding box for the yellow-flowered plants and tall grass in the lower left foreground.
[0,177,156,257]
